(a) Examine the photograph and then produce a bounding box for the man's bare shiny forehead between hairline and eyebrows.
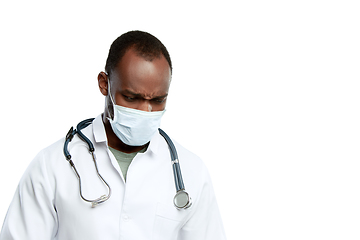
[111,48,171,95]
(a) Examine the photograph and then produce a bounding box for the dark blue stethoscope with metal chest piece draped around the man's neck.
[64,118,192,210]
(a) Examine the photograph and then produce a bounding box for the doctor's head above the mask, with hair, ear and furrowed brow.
[98,31,172,115]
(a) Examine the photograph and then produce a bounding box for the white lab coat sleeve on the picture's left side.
[0,152,57,240]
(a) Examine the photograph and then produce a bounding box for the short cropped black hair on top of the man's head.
[105,31,172,74]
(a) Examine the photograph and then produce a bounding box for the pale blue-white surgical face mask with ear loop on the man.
[108,82,165,146]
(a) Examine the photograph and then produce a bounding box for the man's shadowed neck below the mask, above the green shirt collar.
[102,113,149,153]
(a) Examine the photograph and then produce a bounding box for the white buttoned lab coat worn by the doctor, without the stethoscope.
[0,115,225,240]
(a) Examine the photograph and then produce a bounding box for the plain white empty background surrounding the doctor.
[0,0,360,240]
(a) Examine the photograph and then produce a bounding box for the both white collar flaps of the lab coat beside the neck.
[93,114,161,154]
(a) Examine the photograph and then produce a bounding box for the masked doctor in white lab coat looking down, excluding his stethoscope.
[0,31,225,240]
